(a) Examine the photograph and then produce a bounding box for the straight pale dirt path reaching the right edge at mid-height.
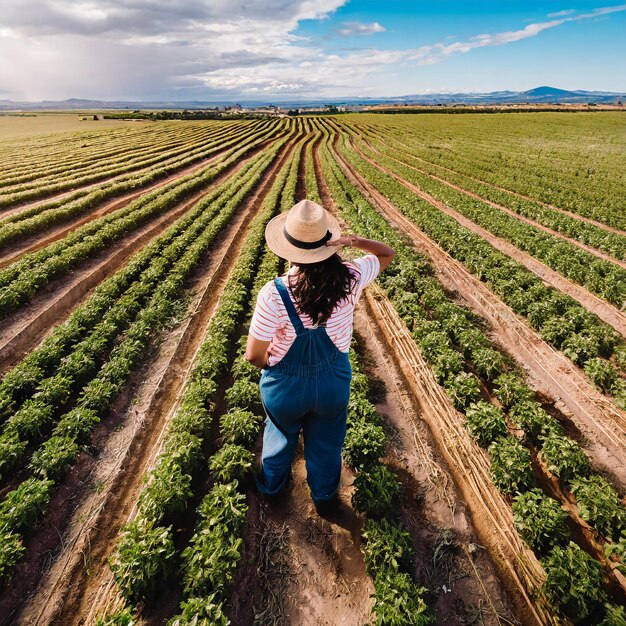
[352,138,626,336]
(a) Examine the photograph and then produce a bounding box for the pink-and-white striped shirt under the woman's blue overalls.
[250,254,380,366]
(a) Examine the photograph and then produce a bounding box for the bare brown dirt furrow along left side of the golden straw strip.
[355,305,515,626]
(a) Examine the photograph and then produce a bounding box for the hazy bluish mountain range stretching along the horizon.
[0,85,626,111]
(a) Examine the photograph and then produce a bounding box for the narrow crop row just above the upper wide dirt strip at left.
[0,118,276,246]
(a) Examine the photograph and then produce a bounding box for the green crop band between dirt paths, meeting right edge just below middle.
[326,124,626,403]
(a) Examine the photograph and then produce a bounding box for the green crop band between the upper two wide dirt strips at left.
[0,123,280,315]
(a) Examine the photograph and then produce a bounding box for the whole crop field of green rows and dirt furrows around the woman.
[0,112,626,626]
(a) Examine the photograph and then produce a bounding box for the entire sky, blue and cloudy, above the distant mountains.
[0,0,626,101]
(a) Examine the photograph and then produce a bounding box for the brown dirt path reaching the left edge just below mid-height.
[0,142,276,373]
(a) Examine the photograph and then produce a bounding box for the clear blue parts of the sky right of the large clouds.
[296,0,626,95]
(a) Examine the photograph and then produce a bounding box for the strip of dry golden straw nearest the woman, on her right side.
[366,288,556,624]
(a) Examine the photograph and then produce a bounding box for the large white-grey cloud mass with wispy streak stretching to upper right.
[0,0,626,100]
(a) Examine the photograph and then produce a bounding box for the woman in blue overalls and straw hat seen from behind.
[246,200,395,513]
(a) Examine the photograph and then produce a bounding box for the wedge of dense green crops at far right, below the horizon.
[348,113,626,230]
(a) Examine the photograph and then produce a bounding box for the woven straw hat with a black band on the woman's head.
[265,200,341,263]
